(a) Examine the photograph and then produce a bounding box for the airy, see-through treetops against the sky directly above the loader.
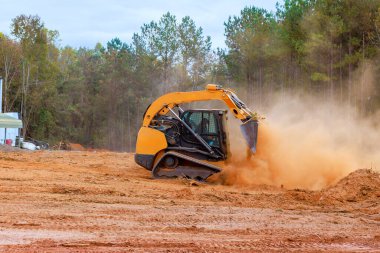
[136,12,211,93]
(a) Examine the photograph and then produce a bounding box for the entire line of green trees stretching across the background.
[0,0,380,151]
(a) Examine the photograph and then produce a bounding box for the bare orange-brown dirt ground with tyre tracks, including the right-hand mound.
[0,151,380,252]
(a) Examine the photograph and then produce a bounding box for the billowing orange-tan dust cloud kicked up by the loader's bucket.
[214,96,380,190]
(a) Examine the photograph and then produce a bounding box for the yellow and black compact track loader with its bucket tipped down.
[135,84,258,181]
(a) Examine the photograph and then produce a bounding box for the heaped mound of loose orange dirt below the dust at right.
[321,169,380,202]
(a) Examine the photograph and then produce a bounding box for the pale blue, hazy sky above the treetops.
[0,0,282,48]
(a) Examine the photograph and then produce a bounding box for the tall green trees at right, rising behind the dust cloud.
[220,0,380,107]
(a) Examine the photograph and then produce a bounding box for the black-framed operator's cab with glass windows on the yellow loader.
[180,109,228,158]
